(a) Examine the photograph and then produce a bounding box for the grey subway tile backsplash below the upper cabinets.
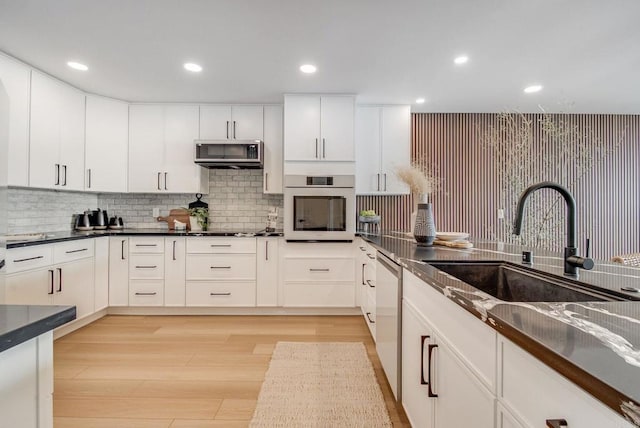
[8,169,283,234]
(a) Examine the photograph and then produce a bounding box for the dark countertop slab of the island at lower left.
[0,305,76,352]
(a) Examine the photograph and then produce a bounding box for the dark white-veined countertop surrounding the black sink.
[361,232,640,426]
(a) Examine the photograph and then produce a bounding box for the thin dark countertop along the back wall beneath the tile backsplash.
[7,228,283,248]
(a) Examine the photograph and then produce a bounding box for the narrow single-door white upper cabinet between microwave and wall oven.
[262,106,283,193]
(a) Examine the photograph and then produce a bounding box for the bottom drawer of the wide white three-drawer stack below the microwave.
[187,281,256,306]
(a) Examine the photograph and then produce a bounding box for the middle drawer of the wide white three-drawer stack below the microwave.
[187,254,256,281]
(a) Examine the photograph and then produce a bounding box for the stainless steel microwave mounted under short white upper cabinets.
[195,140,264,169]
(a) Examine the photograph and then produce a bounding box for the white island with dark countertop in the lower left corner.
[0,305,76,428]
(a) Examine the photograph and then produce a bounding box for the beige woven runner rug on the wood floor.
[250,342,392,428]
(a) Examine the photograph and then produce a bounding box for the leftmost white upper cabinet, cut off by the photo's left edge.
[0,55,31,186]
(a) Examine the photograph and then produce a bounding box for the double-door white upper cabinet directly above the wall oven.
[284,95,355,162]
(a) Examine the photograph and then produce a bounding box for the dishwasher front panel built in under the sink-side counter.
[376,251,402,401]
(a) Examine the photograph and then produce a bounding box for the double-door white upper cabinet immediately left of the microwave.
[129,104,209,193]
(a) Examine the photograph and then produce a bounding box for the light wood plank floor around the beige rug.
[53,316,409,428]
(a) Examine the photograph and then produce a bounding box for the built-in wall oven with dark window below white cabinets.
[284,175,356,241]
